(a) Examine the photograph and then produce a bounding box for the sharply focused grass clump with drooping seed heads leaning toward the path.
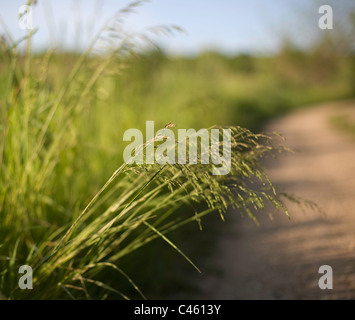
[4,122,287,298]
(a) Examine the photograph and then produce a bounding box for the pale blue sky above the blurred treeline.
[0,0,344,54]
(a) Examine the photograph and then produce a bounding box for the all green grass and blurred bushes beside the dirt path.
[0,0,352,299]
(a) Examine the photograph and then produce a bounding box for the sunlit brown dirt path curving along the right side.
[198,102,355,299]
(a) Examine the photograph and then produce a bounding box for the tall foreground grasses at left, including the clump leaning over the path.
[0,1,287,299]
